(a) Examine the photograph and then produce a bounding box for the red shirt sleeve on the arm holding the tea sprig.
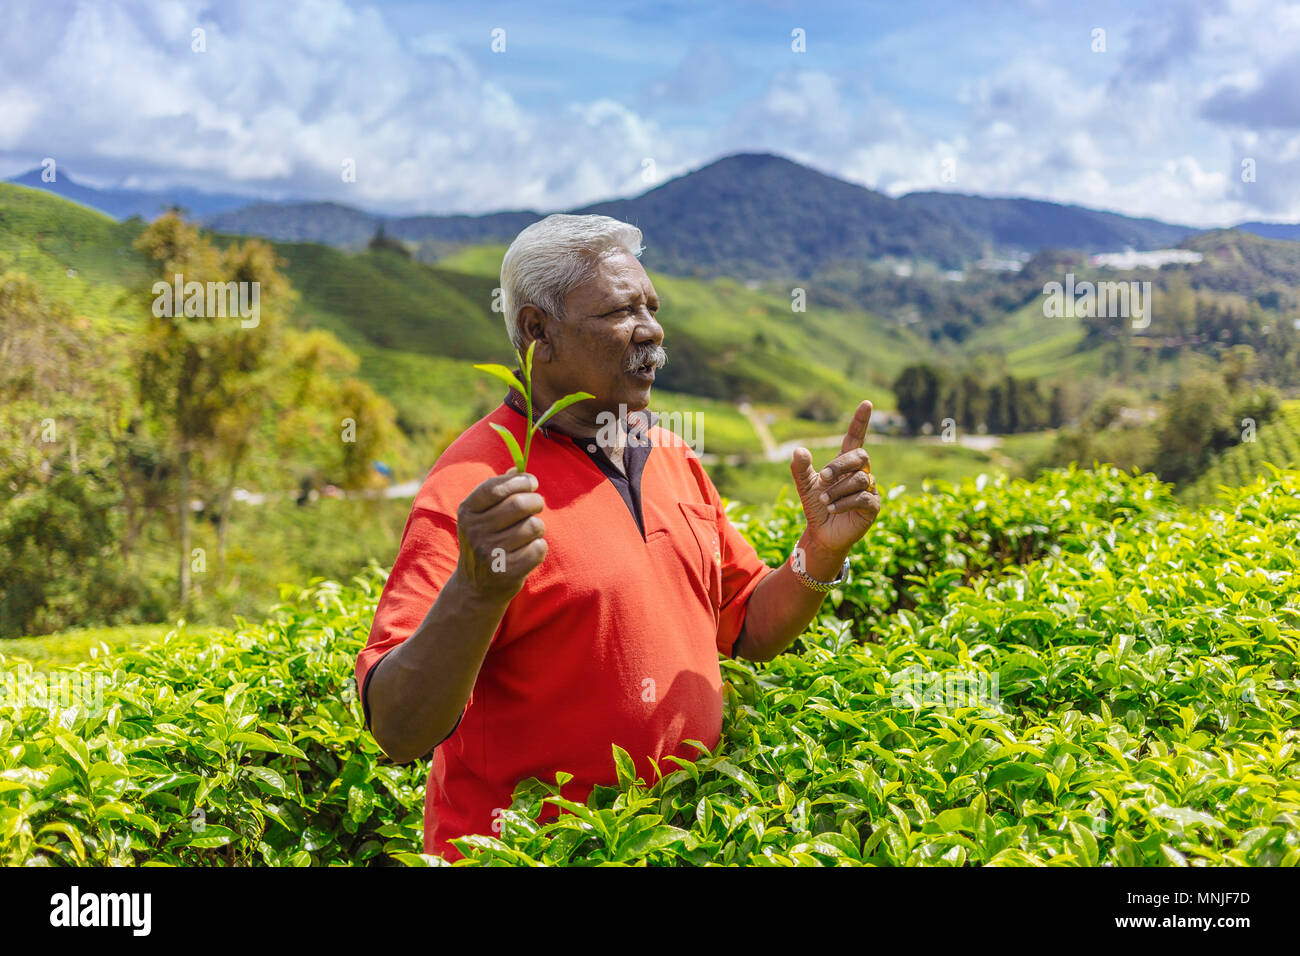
[356,506,460,732]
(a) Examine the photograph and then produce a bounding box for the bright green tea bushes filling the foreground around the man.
[0,470,1300,866]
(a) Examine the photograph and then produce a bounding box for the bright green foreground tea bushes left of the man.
[0,570,425,866]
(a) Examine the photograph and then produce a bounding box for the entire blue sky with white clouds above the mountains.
[0,0,1300,225]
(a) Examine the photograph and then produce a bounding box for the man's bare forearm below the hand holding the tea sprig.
[367,572,510,763]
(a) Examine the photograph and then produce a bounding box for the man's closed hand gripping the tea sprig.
[456,466,546,602]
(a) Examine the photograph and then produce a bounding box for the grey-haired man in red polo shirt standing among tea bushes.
[356,216,880,860]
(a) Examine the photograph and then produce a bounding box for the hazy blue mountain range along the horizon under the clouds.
[10,153,1300,278]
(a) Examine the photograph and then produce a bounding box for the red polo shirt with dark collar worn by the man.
[356,390,772,860]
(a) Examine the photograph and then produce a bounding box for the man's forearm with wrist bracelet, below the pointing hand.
[736,531,846,661]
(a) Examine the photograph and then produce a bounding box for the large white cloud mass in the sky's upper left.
[0,0,675,213]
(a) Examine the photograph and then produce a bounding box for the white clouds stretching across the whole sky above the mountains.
[0,0,1300,225]
